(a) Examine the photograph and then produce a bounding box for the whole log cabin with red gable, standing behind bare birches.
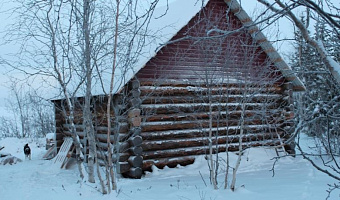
[53,0,305,178]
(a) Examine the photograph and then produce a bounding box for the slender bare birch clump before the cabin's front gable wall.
[178,5,289,191]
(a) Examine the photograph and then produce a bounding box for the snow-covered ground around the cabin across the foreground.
[0,138,340,200]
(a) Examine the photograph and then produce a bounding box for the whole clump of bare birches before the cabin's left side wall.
[0,0,167,193]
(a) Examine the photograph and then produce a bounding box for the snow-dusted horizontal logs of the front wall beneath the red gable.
[140,81,292,171]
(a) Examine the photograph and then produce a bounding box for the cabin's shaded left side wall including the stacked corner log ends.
[54,83,142,178]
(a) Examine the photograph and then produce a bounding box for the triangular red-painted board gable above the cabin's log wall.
[136,0,282,85]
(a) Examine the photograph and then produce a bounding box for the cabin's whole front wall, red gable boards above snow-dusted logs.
[136,0,294,170]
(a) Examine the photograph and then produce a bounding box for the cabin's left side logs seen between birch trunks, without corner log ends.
[54,95,130,169]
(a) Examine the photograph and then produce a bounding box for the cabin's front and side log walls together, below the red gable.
[51,80,294,178]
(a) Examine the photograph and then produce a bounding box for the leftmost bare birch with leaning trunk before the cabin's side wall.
[0,0,101,181]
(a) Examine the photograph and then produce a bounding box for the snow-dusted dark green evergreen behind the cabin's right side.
[291,16,339,139]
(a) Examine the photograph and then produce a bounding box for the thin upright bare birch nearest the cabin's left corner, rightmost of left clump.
[97,0,169,190]
